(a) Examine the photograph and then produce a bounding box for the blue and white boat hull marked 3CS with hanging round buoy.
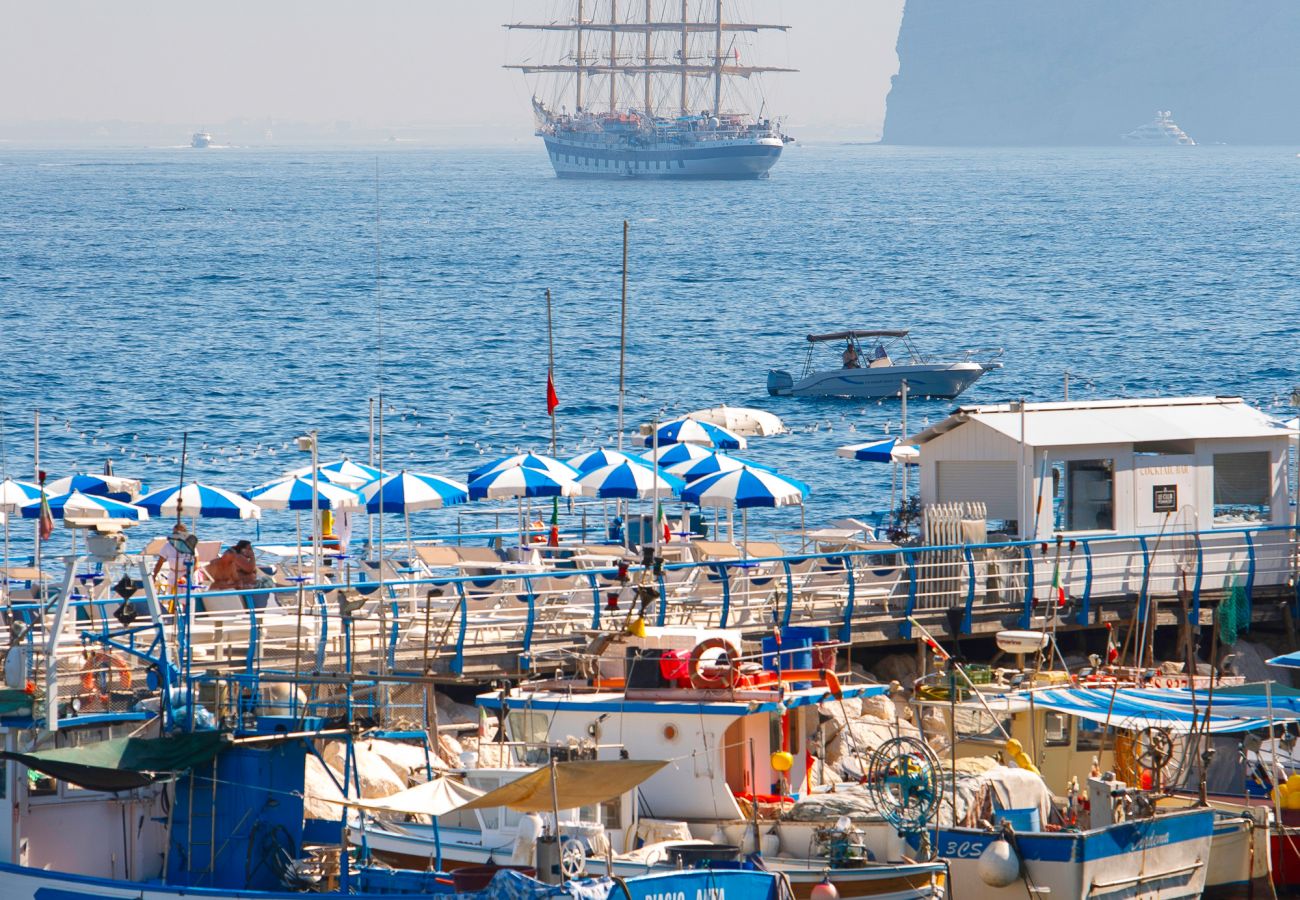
[936,809,1214,900]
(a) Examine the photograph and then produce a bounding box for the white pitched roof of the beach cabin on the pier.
[907,397,1296,447]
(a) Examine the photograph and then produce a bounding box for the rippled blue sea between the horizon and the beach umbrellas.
[0,143,1300,548]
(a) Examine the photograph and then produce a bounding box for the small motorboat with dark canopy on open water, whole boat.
[767,329,1002,399]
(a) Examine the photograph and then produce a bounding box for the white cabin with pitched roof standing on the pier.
[910,397,1296,585]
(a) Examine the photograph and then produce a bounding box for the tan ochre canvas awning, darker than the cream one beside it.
[460,760,668,813]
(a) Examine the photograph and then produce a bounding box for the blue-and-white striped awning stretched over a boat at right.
[1014,688,1300,735]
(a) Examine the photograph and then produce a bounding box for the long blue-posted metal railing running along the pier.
[10,525,1300,719]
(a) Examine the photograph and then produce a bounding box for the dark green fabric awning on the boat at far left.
[0,731,228,791]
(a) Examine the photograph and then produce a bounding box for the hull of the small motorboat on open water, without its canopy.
[767,362,988,399]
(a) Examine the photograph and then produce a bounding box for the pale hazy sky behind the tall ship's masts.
[0,0,904,140]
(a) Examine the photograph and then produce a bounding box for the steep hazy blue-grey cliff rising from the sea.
[884,0,1300,146]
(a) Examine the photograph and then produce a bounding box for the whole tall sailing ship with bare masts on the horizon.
[506,0,794,178]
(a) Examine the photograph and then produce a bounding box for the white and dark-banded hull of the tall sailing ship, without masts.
[543,135,784,179]
